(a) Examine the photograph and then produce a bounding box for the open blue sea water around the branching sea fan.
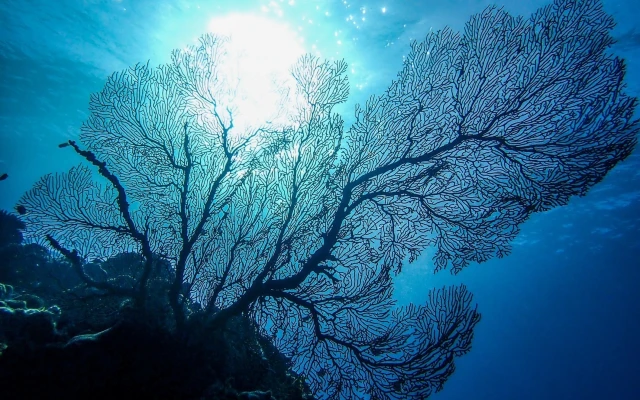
[0,0,640,399]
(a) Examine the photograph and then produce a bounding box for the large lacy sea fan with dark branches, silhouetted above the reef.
[12,0,638,398]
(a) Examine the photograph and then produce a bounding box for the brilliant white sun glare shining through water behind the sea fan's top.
[208,14,304,130]
